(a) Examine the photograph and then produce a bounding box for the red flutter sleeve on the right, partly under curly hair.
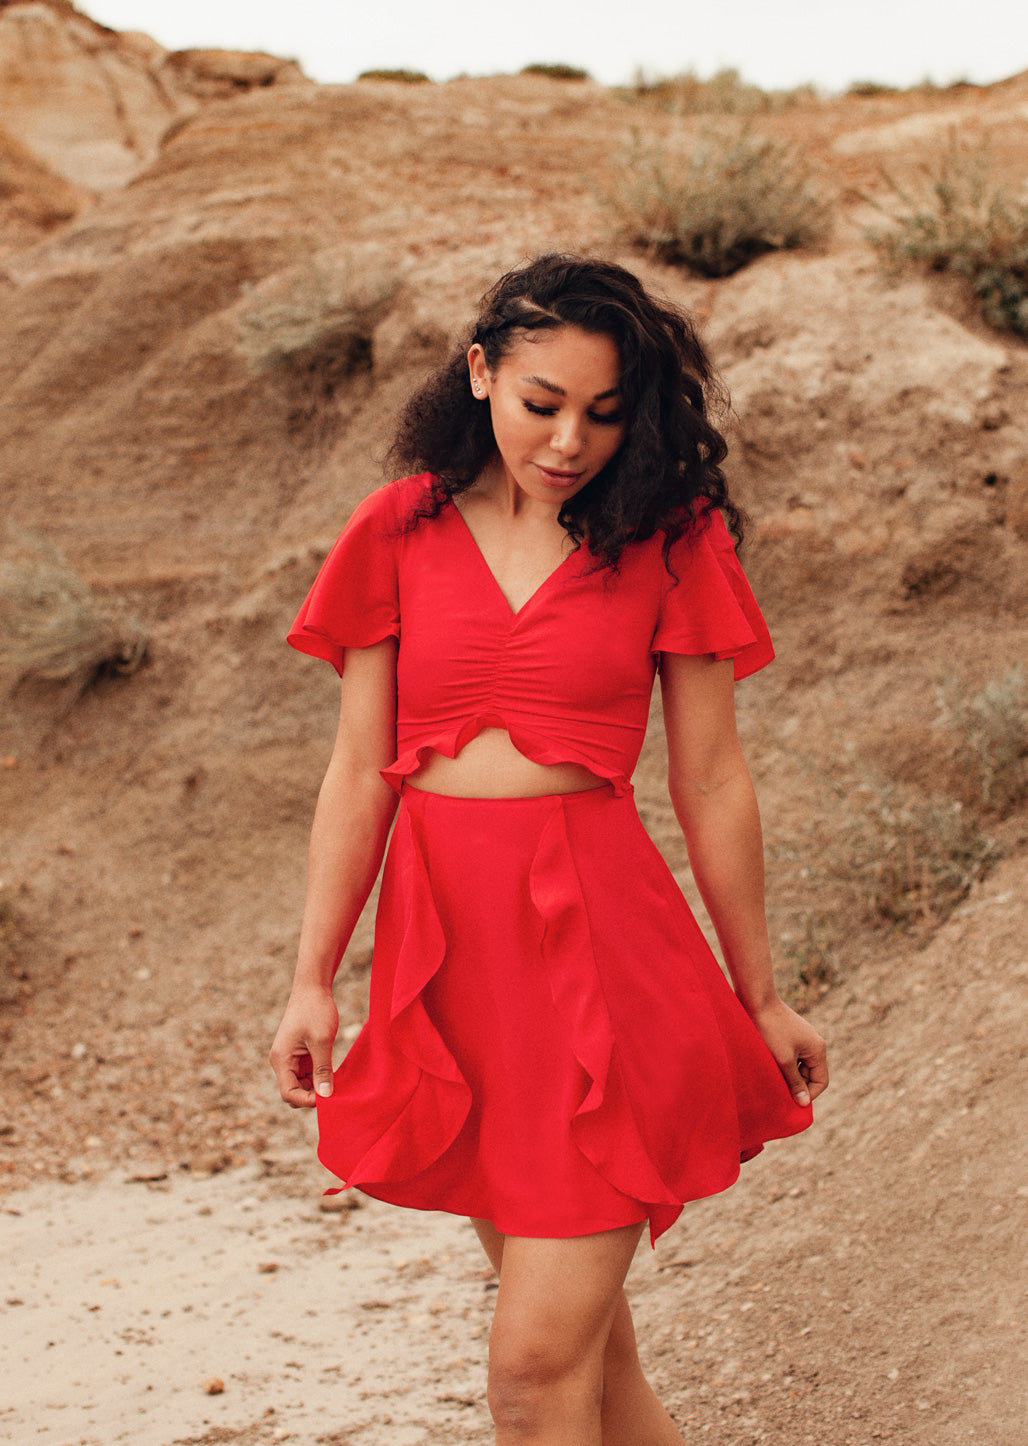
[651,512,775,678]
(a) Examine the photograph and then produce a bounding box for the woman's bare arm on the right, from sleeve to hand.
[661,654,828,1105]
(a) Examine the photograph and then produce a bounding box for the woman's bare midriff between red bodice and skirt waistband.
[405,727,606,798]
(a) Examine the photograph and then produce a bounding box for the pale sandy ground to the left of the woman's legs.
[0,1168,489,1446]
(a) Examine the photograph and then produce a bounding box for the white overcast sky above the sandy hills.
[78,0,1028,90]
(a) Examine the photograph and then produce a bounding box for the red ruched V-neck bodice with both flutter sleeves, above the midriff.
[289,474,774,792]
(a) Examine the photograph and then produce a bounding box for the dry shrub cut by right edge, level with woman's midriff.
[940,664,1028,817]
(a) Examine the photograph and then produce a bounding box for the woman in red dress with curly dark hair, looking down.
[272,256,827,1446]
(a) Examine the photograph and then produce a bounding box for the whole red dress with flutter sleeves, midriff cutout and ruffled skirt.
[289,476,811,1238]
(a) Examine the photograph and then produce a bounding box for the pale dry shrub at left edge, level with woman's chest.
[0,536,146,691]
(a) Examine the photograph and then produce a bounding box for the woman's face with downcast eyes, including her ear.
[467,327,627,508]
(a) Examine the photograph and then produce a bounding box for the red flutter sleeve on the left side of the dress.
[286,487,401,674]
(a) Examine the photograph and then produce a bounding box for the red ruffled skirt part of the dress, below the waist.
[318,787,811,1239]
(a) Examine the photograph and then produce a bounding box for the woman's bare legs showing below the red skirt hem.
[473,1220,682,1446]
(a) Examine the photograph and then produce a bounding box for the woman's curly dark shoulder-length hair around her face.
[389,253,743,568]
